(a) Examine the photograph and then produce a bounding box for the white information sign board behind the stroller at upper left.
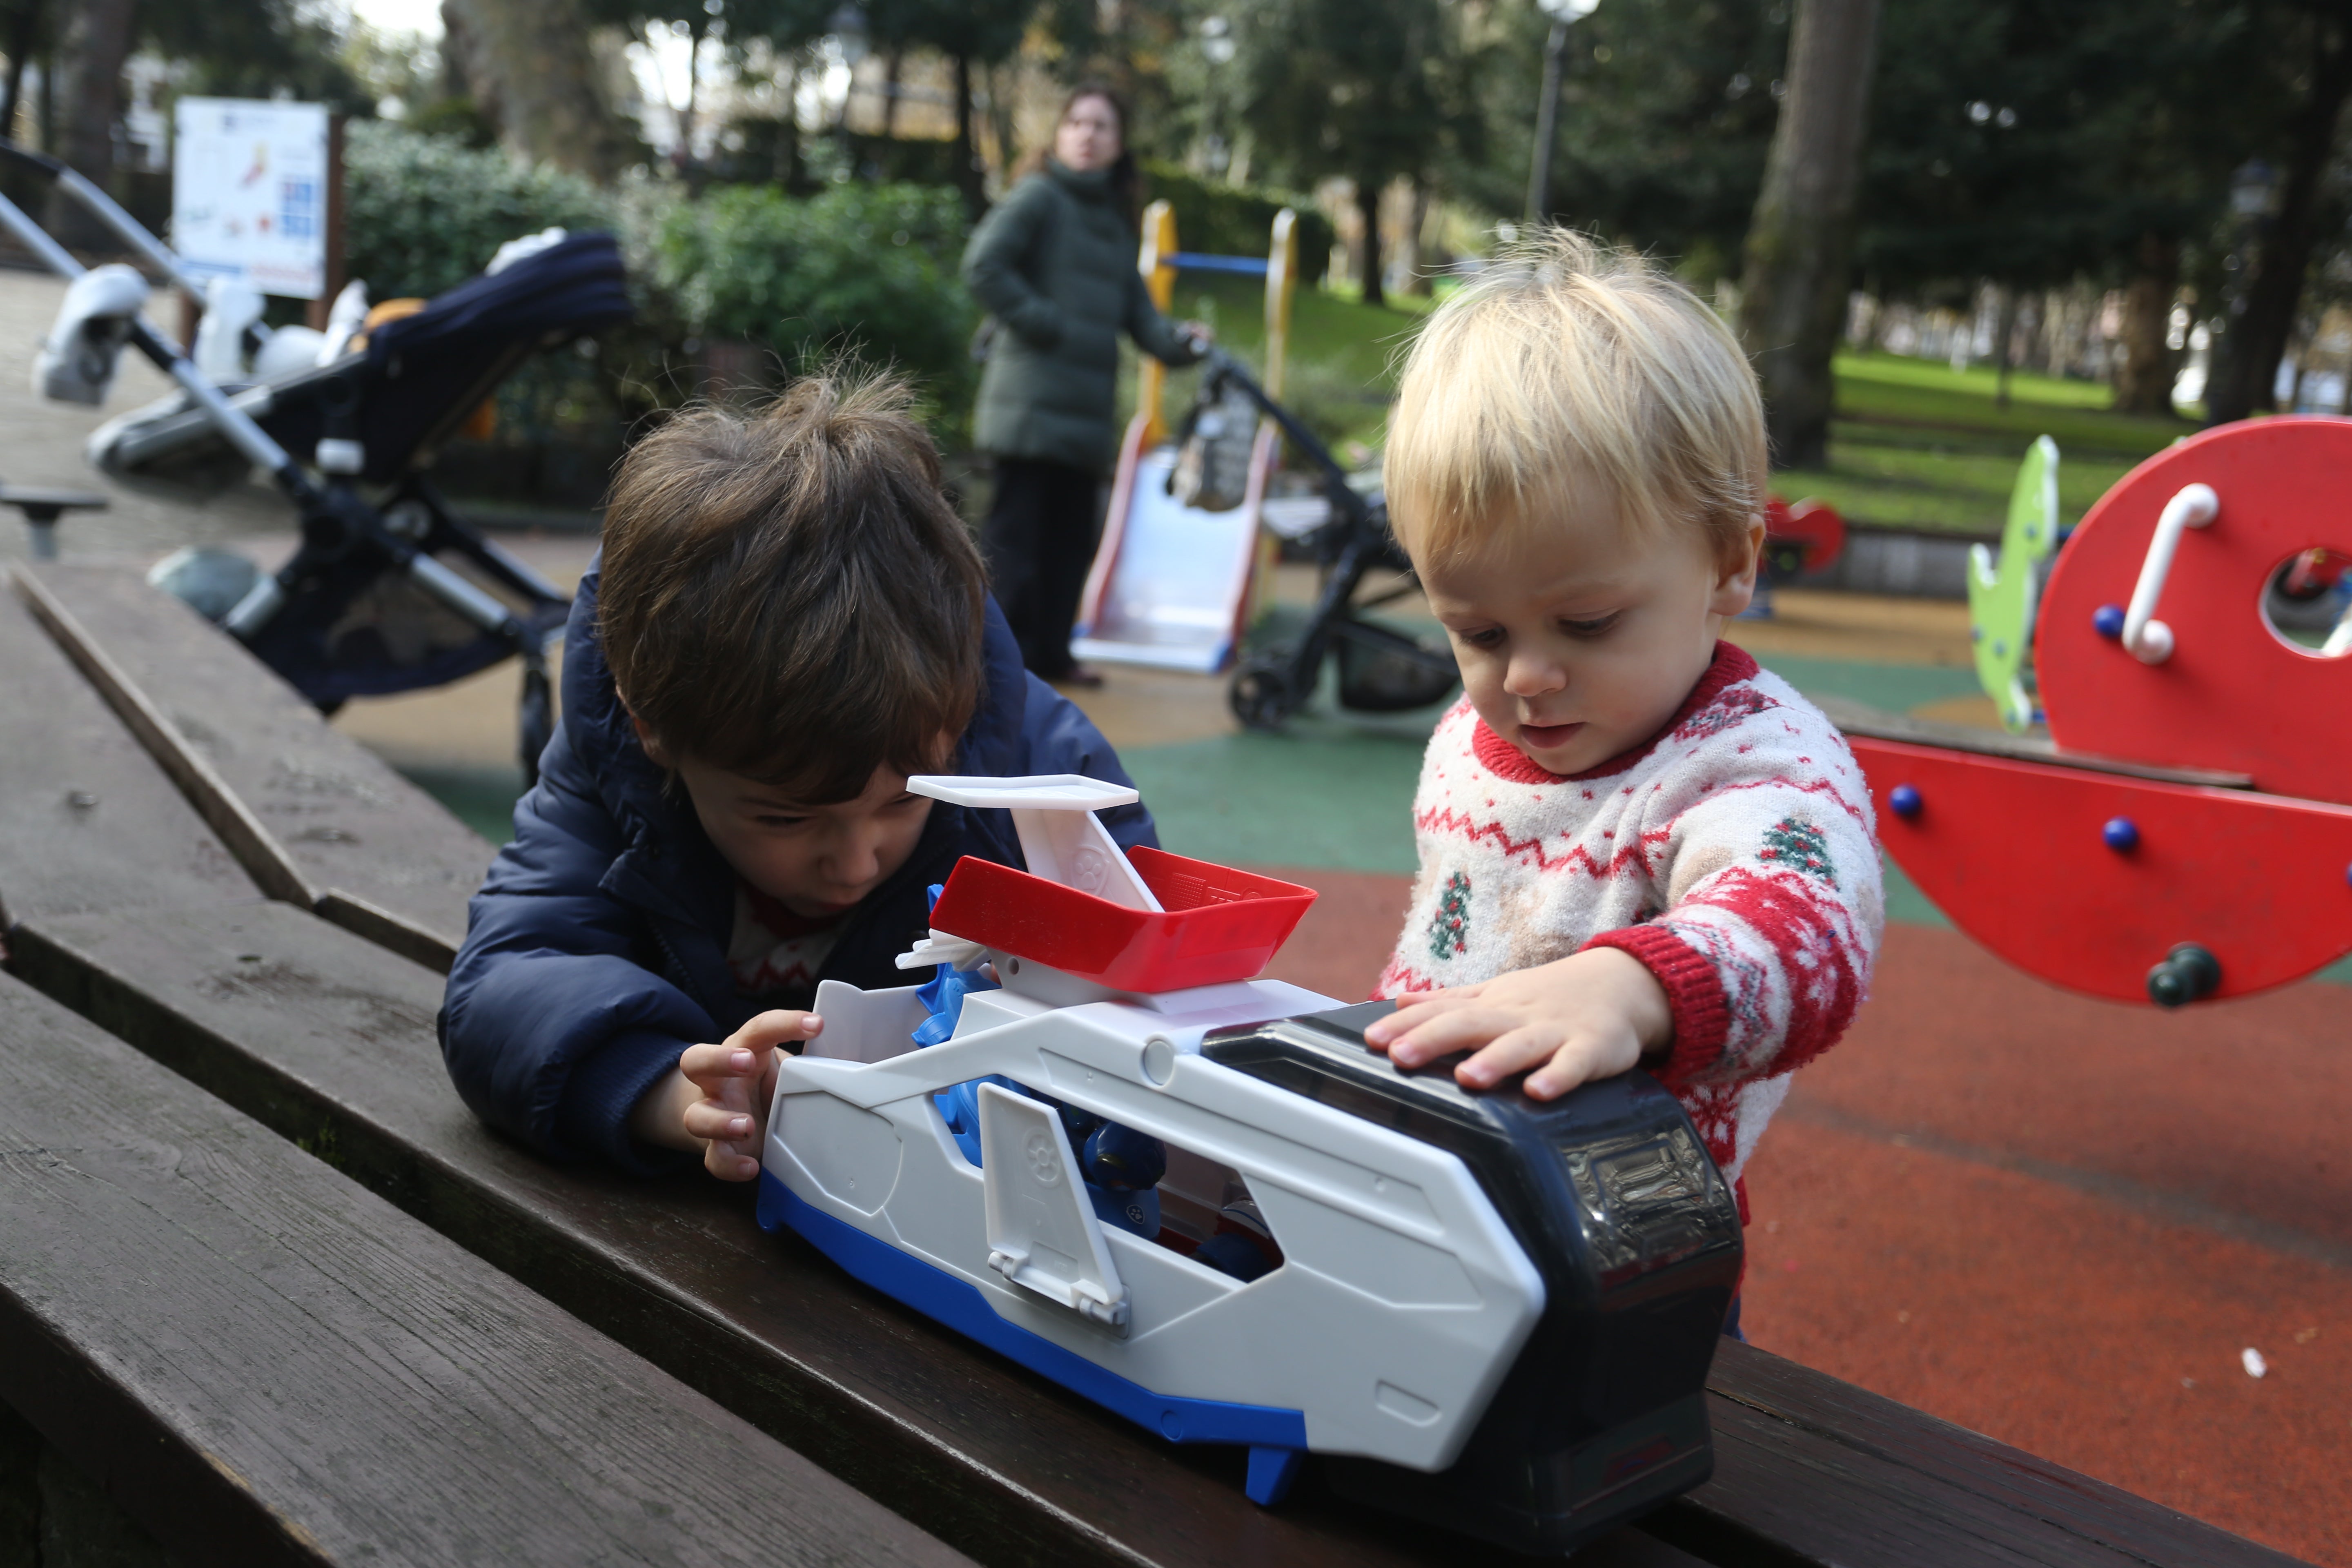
[172,99,329,298]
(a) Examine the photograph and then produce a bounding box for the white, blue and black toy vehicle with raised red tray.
[760,776,1740,1552]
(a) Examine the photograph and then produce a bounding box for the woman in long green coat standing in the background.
[964,82,1209,686]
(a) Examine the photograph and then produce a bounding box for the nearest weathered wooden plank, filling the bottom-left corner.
[0,978,964,1568]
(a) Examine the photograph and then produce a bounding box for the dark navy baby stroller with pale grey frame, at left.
[0,143,630,783]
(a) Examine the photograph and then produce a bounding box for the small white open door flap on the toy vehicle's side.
[981,1084,1129,1333]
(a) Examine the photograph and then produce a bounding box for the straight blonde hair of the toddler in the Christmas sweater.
[1385,228,1766,571]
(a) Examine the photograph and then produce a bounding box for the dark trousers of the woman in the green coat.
[981,459,1103,679]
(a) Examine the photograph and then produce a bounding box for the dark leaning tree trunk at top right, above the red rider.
[2206,19,2352,425]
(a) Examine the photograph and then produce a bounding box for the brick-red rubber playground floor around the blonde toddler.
[1275,870,2352,1566]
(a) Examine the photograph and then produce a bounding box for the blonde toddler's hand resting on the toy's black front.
[1364,947,1675,1100]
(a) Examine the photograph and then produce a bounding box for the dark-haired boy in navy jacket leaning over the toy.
[440,376,1157,1180]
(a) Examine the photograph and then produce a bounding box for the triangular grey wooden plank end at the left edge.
[0,595,261,922]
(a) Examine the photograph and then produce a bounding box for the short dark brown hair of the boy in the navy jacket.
[597,372,985,804]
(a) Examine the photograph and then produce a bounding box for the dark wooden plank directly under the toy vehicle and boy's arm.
[14,905,1461,1568]
